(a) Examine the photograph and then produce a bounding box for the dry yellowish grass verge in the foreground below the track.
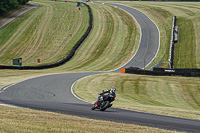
[0,106,180,133]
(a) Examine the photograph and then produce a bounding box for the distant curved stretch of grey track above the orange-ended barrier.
[105,3,160,68]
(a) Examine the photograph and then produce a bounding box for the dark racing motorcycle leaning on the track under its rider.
[91,91,115,111]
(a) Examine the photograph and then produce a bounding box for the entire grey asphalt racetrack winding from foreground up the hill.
[0,4,200,132]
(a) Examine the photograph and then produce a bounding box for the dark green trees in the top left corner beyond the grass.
[0,0,29,15]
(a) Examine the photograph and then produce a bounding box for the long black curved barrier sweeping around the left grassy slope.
[0,3,93,70]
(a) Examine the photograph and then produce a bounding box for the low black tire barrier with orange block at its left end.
[121,67,200,77]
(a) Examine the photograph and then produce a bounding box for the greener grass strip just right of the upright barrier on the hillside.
[174,17,197,68]
